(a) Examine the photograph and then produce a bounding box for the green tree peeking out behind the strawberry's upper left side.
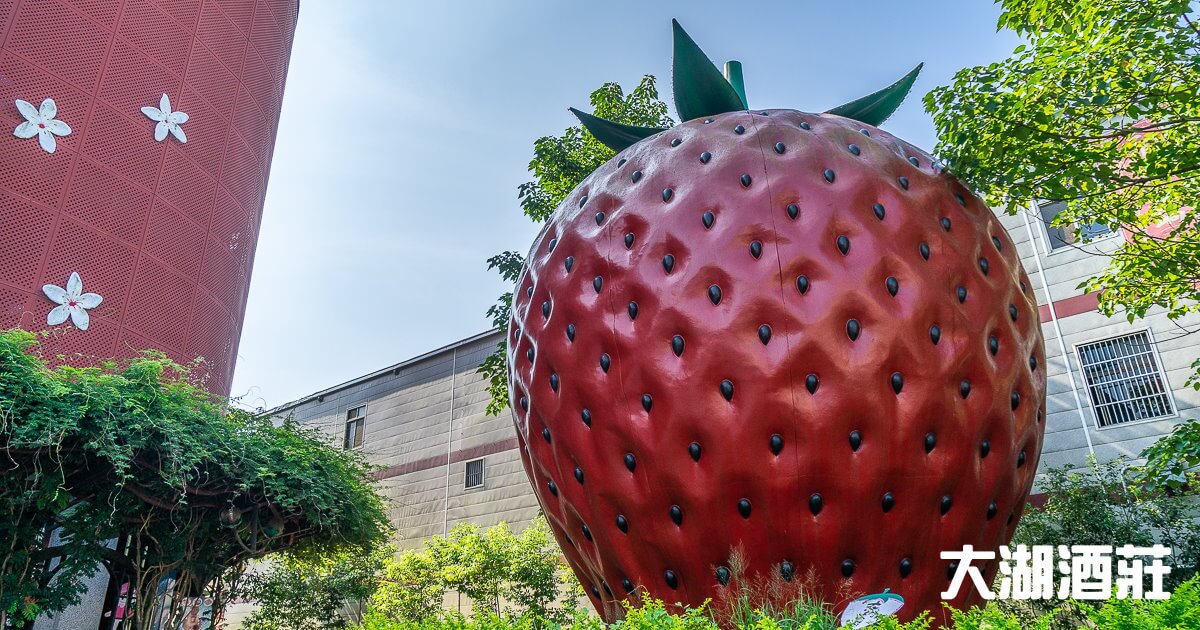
[479,74,674,415]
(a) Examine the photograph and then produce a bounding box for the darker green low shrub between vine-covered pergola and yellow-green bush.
[241,546,395,630]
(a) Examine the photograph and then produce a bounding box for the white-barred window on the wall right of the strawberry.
[1076,332,1175,427]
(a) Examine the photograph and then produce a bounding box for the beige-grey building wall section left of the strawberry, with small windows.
[268,332,538,548]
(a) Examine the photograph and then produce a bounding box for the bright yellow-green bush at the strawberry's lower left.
[370,518,563,623]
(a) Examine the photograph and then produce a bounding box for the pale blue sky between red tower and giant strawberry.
[233,0,1019,407]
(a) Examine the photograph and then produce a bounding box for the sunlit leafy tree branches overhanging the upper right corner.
[925,0,1200,379]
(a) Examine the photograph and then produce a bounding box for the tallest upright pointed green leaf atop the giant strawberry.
[671,19,746,122]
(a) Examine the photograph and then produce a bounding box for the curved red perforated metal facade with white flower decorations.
[0,0,298,394]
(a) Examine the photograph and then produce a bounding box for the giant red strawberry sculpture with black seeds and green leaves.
[509,24,1045,618]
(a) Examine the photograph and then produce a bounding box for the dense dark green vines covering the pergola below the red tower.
[0,330,386,630]
